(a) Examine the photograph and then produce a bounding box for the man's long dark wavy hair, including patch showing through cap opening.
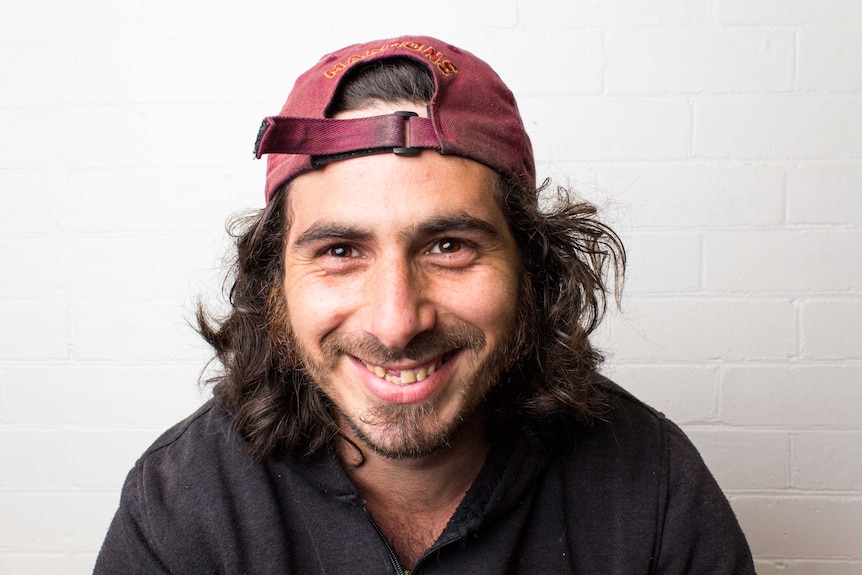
[197,59,626,458]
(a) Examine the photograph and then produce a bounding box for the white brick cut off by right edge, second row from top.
[797,24,862,92]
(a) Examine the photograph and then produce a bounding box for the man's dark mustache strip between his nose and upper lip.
[321,325,485,365]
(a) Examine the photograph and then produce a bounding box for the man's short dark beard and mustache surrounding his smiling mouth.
[292,325,515,459]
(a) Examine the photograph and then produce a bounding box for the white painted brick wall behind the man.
[0,0,862,575]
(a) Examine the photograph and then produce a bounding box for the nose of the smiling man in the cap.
[365,258,436,349]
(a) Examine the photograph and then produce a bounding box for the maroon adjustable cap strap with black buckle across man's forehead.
[254,113,440,158]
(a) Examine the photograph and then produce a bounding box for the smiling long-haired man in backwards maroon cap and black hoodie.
[96,37,754,575]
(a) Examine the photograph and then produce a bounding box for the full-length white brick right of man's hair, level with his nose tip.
[612,298,796,362]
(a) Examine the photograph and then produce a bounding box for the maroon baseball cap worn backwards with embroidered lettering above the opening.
[254,36,536,202]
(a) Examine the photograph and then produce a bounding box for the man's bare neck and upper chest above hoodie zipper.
[339,417,490,568]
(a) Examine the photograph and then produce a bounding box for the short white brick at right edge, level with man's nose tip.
[802,300,862,359]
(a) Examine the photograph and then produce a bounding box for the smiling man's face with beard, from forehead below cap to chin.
[284,146,521,458]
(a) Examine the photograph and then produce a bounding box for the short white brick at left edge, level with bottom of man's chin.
[0,428,72,489]
